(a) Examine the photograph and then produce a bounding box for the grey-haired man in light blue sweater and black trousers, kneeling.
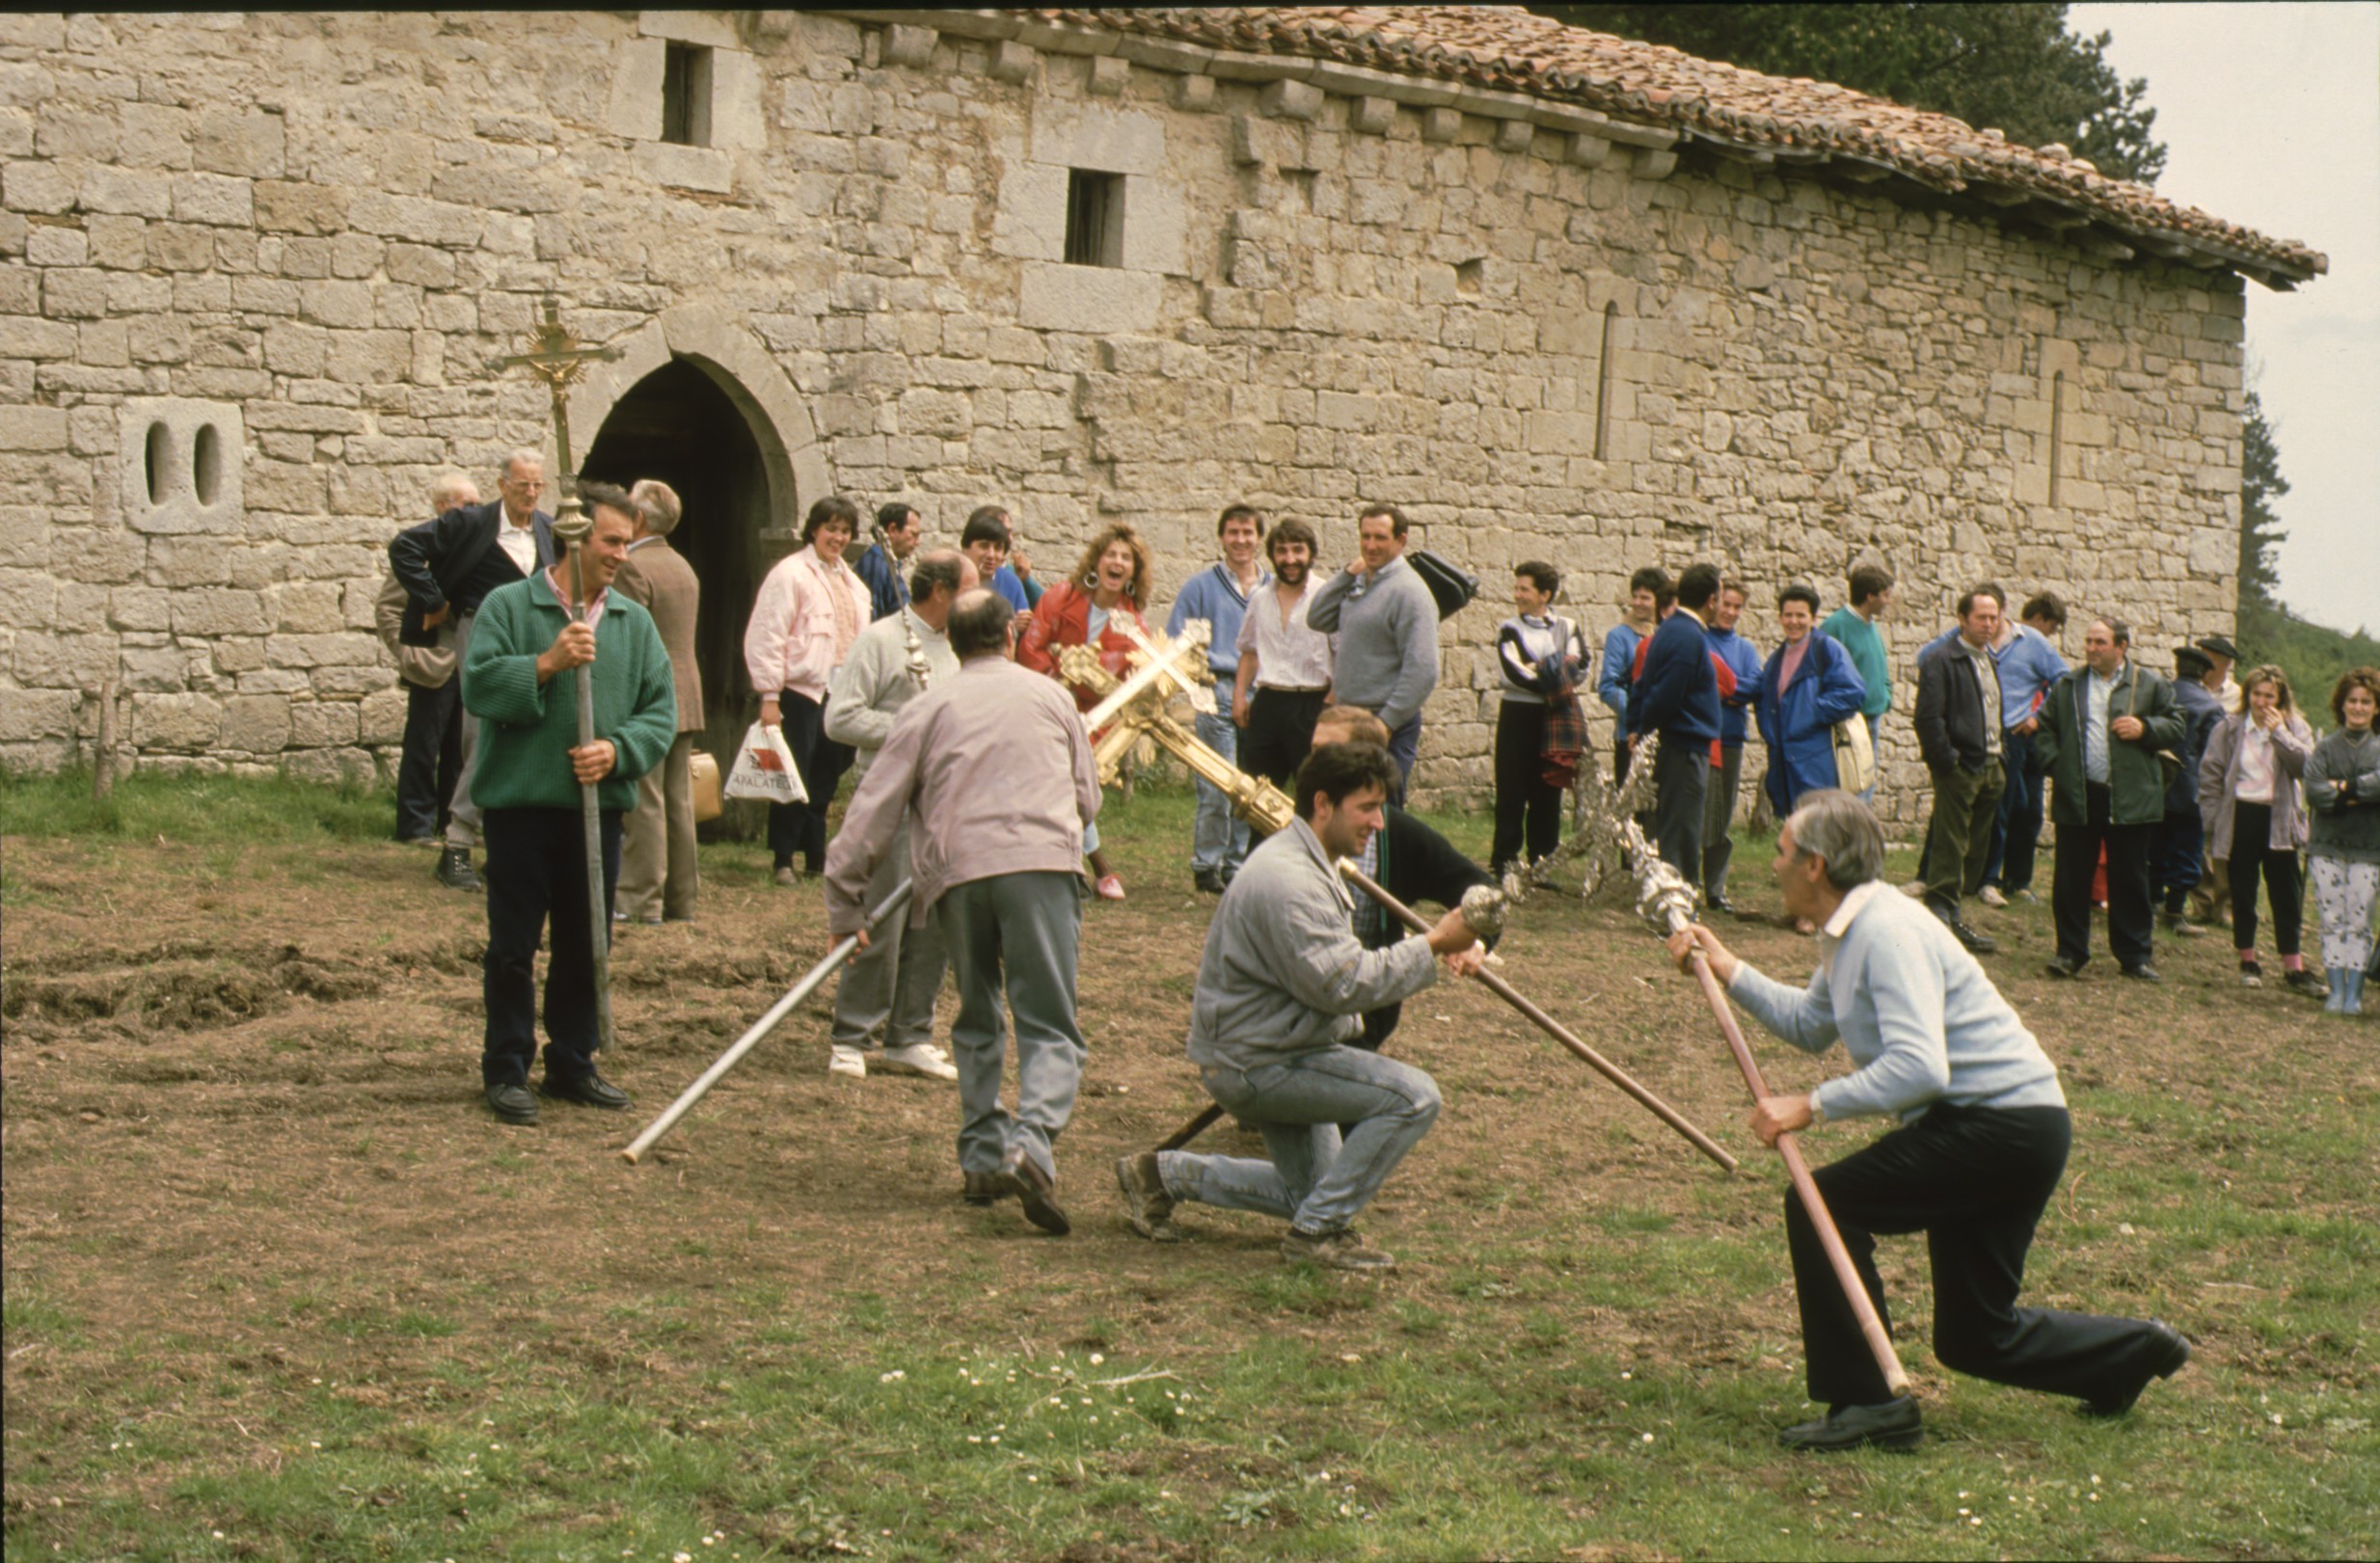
[1671,788,2190,1449]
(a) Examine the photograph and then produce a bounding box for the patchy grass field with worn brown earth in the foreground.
[0,775,2380,1563]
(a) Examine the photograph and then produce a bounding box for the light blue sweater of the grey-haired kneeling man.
[1728,880,2066,1123]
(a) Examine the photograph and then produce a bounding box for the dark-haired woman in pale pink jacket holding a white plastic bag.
[744,495,869,885]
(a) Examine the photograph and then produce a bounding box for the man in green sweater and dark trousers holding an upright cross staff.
[462,483,678,1123]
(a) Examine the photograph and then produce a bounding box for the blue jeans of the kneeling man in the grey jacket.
[1156,1044,1438,1235]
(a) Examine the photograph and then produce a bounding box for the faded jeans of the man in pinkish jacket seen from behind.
[933,873,1088,1180]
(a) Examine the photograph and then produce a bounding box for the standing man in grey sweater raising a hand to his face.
[1307,504,1438,809]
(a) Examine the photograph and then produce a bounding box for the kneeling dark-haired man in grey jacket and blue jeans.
[1116,744,1485,1271]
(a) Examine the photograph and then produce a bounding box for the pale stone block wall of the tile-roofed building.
[0,12,2242,823]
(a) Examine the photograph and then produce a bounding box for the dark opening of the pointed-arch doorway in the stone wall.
[581,360,783,754]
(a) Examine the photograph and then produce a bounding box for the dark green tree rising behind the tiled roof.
[1530,2,2166,183]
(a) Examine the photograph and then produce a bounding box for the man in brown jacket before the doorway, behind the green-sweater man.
[611,478,702,923]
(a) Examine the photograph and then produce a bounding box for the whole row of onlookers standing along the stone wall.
[381,452,2380,1075]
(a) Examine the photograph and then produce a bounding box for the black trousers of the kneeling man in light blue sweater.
[1785,1103,2163,1406]
